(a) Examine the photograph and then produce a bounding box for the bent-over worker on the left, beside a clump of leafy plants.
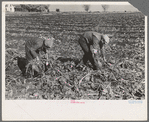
[25,37,54,74]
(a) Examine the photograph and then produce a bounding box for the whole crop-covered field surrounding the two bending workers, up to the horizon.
[5,13,145,100]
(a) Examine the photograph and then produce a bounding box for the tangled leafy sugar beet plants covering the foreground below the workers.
[5,34,145,100]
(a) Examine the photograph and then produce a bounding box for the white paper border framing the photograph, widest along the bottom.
[2,1,148,121]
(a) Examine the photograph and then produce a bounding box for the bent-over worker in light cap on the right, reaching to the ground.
[79,31,109,70]
